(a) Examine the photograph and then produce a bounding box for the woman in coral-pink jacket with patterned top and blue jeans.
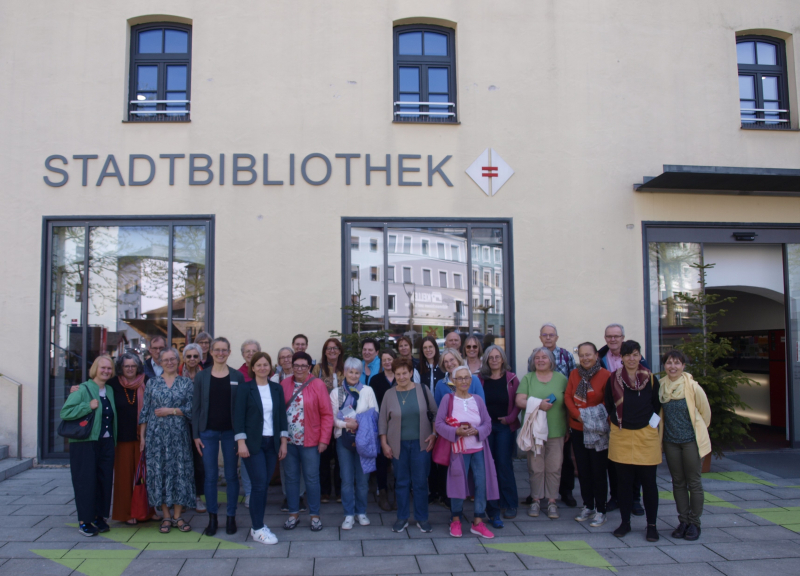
[281,352,333,532]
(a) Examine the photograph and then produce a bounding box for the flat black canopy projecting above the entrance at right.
[633,164,800,196]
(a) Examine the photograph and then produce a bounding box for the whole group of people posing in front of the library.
[61,324,711,544]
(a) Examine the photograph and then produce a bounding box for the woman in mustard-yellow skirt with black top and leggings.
[605,340,661,542]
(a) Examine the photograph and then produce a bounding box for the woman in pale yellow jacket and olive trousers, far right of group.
[659,350,711,540]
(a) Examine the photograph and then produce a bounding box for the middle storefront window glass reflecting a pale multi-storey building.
[343,221,511,360]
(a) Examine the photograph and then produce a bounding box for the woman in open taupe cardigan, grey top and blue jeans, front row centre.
[378,358,436,533]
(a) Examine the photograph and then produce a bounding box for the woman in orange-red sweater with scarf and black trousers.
[564,342,611,528]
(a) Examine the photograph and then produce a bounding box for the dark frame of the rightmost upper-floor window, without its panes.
[736,34,792,130]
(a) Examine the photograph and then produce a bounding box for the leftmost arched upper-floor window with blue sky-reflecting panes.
[128,23,192,122]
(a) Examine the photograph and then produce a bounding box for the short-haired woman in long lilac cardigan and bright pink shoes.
[436,366,499,538]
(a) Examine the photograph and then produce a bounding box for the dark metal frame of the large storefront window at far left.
[37,214,216,464]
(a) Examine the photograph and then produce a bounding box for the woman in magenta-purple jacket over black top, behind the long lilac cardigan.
[479,345,520,528]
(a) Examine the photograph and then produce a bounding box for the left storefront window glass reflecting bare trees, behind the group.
[42,220,209,457]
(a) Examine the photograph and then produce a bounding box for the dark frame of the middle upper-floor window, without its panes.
[392,24,458,124]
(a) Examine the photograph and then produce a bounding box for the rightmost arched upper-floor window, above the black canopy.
[736,36,791,129]
